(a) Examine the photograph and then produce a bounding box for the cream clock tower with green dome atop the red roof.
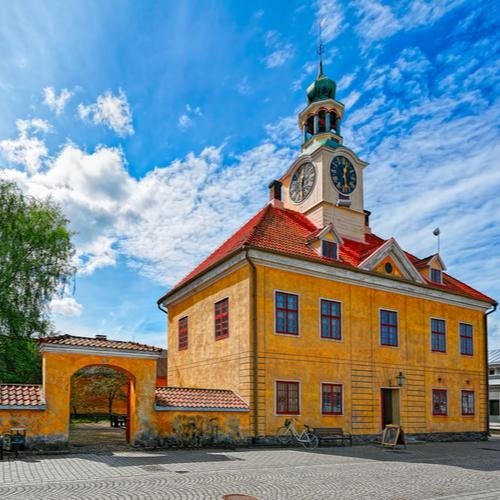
[280,60,369,241]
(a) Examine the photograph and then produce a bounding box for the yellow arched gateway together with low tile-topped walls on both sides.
[0,335,249,447]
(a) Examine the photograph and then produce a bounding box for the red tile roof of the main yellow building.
[158,205,495,303]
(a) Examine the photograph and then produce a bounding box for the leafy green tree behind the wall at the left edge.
[0,179,75,383]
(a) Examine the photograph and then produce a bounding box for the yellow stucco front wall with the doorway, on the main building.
[257,266,486,435]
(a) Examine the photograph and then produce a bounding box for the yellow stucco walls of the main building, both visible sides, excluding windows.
[169,260,486,435]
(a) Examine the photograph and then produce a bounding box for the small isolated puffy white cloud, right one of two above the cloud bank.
[78,89,134,136]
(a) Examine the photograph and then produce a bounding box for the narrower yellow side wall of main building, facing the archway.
[168,266,250,401]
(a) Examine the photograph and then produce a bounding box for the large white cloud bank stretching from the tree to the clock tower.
[0,125,299,285]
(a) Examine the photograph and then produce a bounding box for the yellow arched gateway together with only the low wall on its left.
[0,335,162,446]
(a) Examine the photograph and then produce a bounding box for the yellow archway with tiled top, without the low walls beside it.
[40,335,161,444]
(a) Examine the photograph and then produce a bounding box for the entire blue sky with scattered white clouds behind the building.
[0,0,500,347]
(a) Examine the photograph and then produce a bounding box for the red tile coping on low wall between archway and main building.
[156,387,249,410]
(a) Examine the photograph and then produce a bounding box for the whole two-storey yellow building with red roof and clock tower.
[158,63,496,439]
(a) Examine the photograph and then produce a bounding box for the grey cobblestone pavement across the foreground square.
[0,437,500,500]
